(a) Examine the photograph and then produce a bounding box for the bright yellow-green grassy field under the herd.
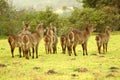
[0,35,120,80]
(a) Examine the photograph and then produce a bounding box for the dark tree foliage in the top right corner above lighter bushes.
[81,0,120,13]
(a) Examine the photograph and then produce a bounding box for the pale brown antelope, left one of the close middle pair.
[44,28,53,54]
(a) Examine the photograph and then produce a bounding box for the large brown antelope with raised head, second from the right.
[67,23,93,56]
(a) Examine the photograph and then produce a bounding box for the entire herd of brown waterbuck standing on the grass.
[8,22,111,59]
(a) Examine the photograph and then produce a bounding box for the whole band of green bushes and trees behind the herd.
[0,0,120,36]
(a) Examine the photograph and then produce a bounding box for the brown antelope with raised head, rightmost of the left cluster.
[30,23,44,58]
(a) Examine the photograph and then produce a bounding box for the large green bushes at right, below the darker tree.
[69,7,120,32]
